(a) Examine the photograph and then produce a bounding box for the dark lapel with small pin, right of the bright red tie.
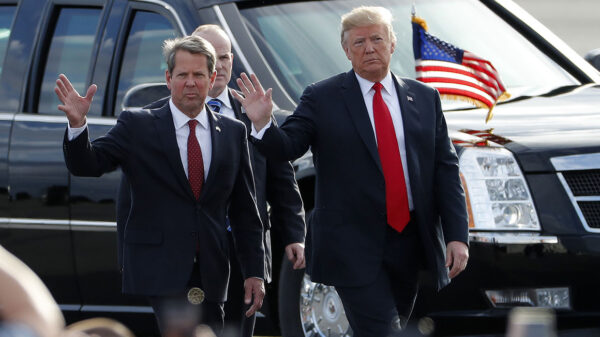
[392,74,421,194]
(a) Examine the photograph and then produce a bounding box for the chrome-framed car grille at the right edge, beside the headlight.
[551,153,600,232]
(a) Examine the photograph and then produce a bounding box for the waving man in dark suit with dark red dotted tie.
[55,36,265,335]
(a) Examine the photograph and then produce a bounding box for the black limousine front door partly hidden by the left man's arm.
[70,1,182,331]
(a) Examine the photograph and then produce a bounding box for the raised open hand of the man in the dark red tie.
[54,74,98,128]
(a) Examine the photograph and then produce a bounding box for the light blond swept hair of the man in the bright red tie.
[341,6,396,46]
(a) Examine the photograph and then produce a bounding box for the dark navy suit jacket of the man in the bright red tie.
[251,71,468,288]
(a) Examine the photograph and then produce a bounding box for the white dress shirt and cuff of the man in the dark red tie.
[67,99,212,181]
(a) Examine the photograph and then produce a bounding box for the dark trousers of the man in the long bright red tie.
[336,221,423,337]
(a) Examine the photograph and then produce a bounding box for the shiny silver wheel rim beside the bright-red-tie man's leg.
[300,275,352,337]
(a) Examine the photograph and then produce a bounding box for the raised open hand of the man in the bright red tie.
[233,73,273,131]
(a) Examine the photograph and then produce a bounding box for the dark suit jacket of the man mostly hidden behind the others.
[131,88,306,282]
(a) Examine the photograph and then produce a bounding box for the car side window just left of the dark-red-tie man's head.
[115,11,177,113]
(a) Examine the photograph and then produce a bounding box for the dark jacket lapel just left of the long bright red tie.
[342,70,383,173]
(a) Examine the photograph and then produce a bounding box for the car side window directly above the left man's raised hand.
[38,8,101,114]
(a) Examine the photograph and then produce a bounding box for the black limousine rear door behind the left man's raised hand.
[5,1,104,314]
